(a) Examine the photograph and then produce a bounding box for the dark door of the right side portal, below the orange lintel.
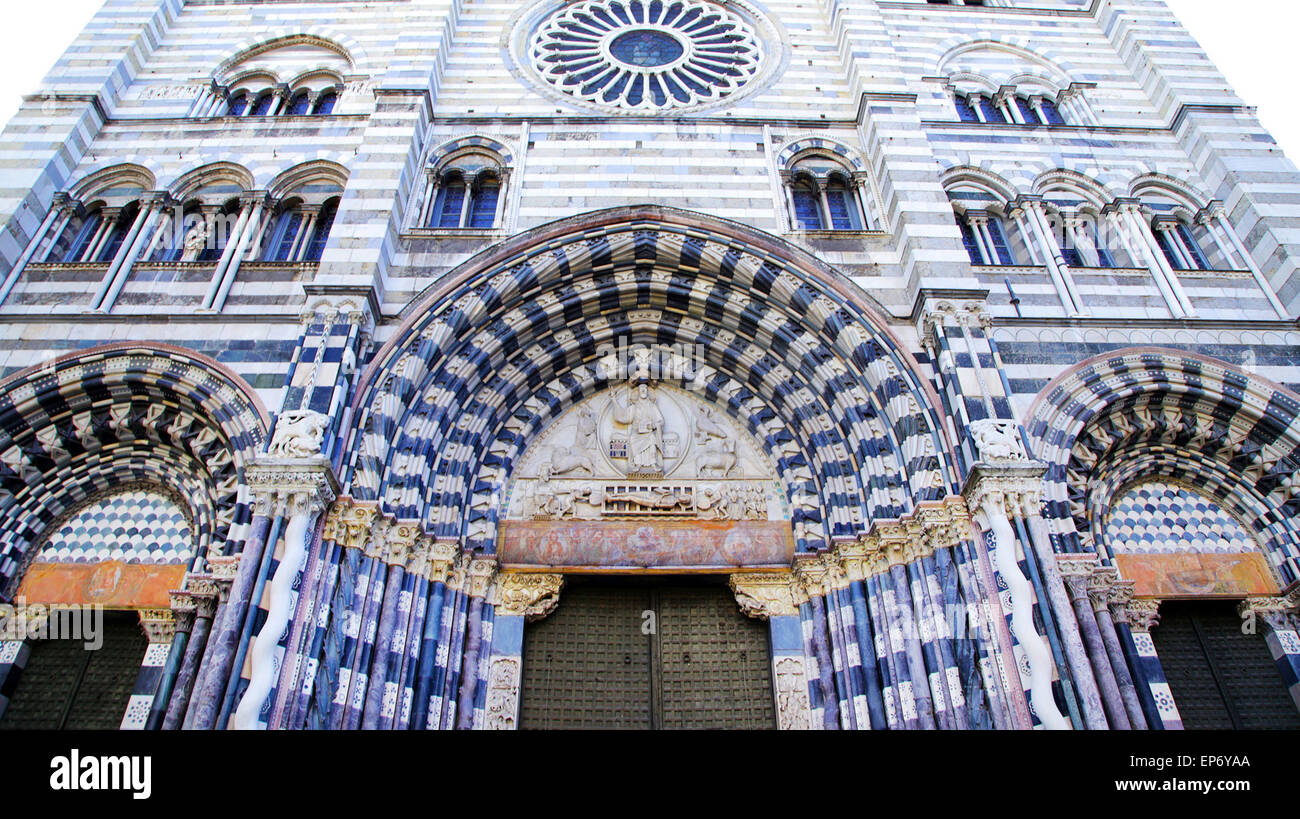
[1151,602,1300,729]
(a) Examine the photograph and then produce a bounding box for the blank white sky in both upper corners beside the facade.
[0,0,1300,163]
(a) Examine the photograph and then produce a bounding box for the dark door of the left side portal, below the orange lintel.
[0,612,148,731]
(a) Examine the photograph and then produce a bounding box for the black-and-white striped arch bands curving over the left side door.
[0,345,267,593]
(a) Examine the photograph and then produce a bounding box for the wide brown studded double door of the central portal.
[520,584,776,728]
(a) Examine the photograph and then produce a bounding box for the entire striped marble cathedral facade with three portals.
[0,0,1300,731]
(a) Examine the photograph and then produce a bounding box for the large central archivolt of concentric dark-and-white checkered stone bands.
[345,207,954,549]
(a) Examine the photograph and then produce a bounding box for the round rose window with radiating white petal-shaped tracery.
[529,0,763,113]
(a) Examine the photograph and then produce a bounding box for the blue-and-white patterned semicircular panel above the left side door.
[38,489,194,564]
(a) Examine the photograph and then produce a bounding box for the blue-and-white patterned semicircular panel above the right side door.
[1105,481,1257,554]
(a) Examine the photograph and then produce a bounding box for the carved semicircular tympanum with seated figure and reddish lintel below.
[498,381,794,568]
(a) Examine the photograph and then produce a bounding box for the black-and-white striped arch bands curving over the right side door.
[1027,348,1300,584]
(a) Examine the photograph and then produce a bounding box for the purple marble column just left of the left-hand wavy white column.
[185,515,270,731]
